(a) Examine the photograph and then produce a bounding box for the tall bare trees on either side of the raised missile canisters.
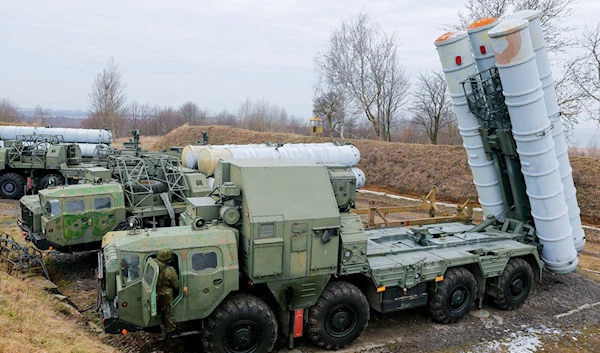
[313,0,600,144]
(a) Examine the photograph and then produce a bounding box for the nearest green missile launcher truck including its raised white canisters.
[98,11,585,353]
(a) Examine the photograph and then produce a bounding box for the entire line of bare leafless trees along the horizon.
[0,0,600,144]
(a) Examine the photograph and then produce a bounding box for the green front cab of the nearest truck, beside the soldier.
[98,224,239,333]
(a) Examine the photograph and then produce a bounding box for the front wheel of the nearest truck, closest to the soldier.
[202,294,277,353]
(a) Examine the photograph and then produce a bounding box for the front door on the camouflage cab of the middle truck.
[63,198,92,243]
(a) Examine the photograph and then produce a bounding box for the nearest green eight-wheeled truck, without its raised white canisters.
[98,160,544,353]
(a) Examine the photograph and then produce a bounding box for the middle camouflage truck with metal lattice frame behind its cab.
[18,153,211,252]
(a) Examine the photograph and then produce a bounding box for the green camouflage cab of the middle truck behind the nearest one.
[18,182,126,252]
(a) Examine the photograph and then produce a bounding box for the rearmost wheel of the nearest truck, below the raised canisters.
[494,258,533,310]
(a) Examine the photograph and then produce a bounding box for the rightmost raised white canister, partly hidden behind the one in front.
[508,10,585,252]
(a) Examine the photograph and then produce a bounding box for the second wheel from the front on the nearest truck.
[306,281,370,349]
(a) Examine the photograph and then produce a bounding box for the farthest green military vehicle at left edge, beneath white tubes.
[0,135,106,199]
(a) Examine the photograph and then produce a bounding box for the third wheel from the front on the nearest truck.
[428,267,477,324]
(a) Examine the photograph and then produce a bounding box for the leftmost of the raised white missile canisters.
[435,31,505,219]
